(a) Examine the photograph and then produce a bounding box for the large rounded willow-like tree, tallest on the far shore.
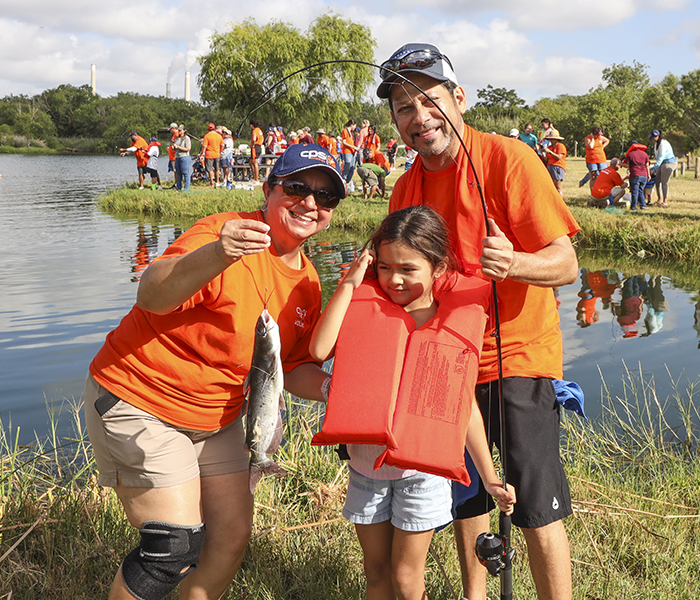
[198,13,376,136]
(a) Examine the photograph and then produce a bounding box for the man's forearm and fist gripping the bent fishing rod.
[480,219,578,287]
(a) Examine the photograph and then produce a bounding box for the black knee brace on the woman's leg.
[122,521,205,600]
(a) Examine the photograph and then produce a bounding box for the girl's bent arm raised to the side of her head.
[309,250,374,360]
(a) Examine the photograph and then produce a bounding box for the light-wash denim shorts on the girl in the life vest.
[343,467,452,531]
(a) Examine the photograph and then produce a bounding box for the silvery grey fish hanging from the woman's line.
[245,308,287,495]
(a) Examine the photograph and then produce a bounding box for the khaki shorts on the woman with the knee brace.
[84,374,249,488]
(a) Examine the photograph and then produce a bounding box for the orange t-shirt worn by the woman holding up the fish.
[90,211,321,431]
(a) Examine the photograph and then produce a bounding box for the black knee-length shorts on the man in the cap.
[456,377,572,528]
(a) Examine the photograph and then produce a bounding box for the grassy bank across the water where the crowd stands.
[100,158,700,262]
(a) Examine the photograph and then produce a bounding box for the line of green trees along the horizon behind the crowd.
[0,12,700,155]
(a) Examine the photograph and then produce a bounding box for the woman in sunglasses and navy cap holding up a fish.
[84,144,347,600]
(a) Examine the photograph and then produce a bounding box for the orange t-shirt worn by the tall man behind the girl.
[389,126,579,383]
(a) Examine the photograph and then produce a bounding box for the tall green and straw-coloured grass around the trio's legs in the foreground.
[0,369,700,600]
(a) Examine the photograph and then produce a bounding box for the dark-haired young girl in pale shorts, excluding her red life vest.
[310,206,515,600]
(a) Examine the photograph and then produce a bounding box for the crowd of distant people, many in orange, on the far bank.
[119,113,678,210]
